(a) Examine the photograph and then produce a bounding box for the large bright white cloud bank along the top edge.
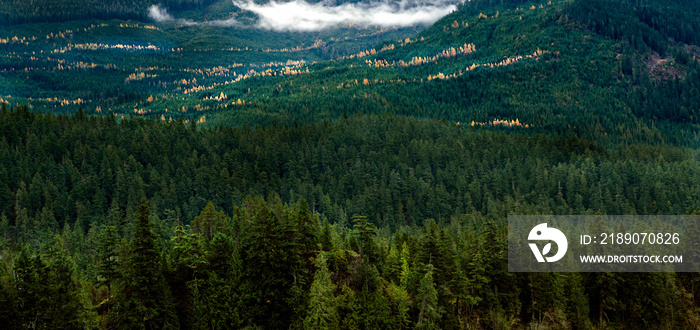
[232,0,456,31]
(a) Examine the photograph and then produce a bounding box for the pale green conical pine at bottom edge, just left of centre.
[304,252,340,329]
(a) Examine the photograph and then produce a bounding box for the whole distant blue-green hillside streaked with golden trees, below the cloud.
[0,0,700,147]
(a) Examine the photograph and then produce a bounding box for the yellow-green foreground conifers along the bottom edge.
[0,196,700,329]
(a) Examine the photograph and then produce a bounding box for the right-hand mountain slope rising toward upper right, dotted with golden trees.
[189,1,700,145]
